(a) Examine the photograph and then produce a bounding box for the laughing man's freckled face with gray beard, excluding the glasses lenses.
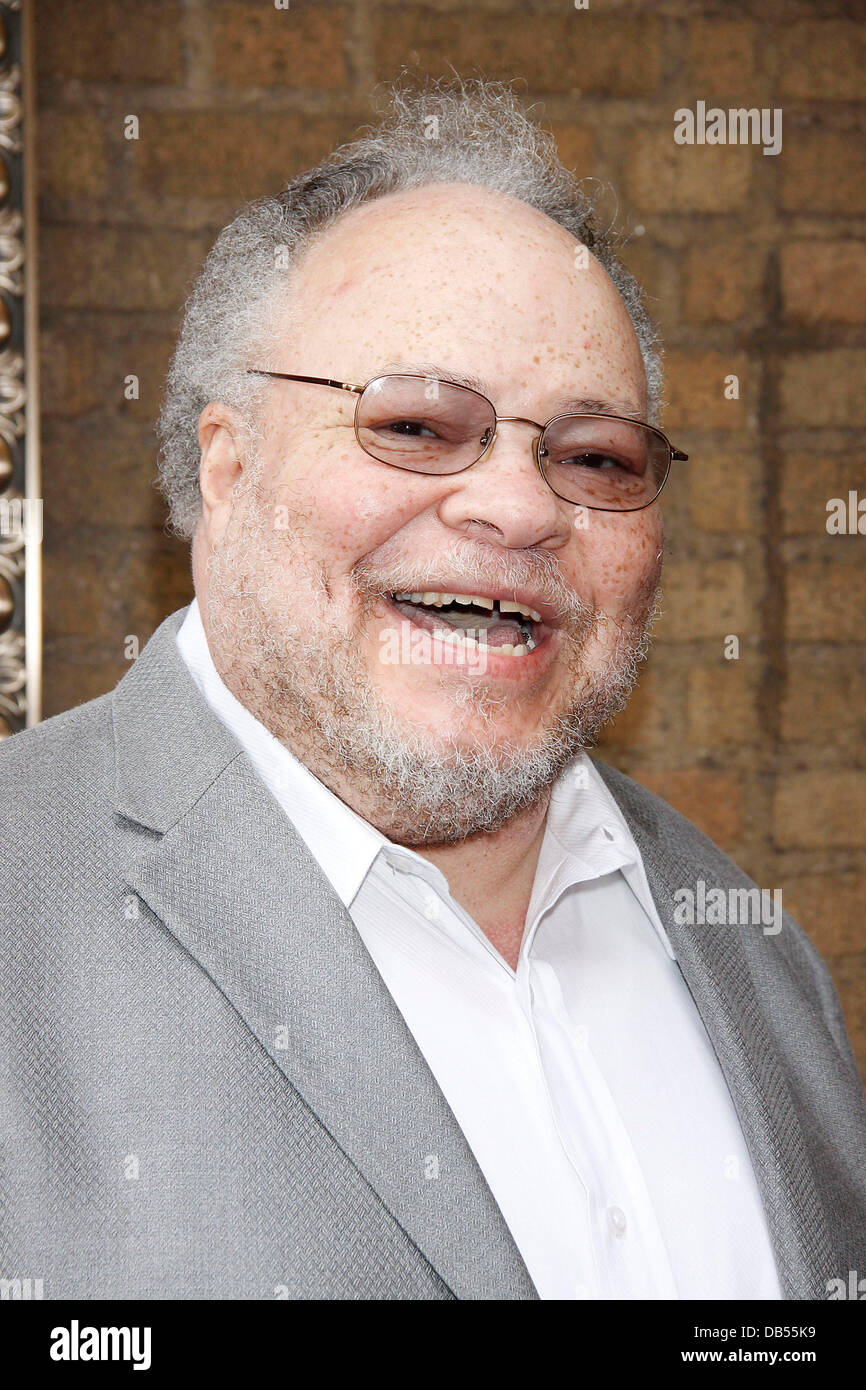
[196,185,662,842]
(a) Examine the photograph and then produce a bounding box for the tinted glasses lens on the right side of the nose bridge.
[541,416,670,512]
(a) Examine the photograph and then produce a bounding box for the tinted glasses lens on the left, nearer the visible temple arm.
[356,375,495,474]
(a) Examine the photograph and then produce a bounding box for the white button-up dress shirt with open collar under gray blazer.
[178,602,781,1298]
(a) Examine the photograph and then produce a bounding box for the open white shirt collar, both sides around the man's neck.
[177,599,674,958]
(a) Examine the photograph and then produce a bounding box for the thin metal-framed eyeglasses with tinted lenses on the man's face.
[249,368,688,512]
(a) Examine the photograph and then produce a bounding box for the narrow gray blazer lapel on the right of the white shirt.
[595,760,837,1298]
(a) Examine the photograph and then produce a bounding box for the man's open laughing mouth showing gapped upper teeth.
[389,589,548,659]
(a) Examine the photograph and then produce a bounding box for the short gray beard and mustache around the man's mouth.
[206,483,660,847]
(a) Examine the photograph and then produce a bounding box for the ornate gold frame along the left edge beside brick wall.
[0,0,42,738]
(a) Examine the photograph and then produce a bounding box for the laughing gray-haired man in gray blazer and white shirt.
[0,83,866,1300]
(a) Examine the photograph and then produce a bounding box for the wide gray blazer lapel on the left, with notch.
[114,612,537,1300]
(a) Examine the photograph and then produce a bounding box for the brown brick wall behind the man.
[36,0,866,1070]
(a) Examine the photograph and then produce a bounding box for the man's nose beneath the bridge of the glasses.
[438,416,574,550]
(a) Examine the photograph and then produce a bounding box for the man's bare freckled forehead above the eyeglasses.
[283,183,645,404]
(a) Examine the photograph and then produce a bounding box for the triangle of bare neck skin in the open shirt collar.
[416,791,550,970]
